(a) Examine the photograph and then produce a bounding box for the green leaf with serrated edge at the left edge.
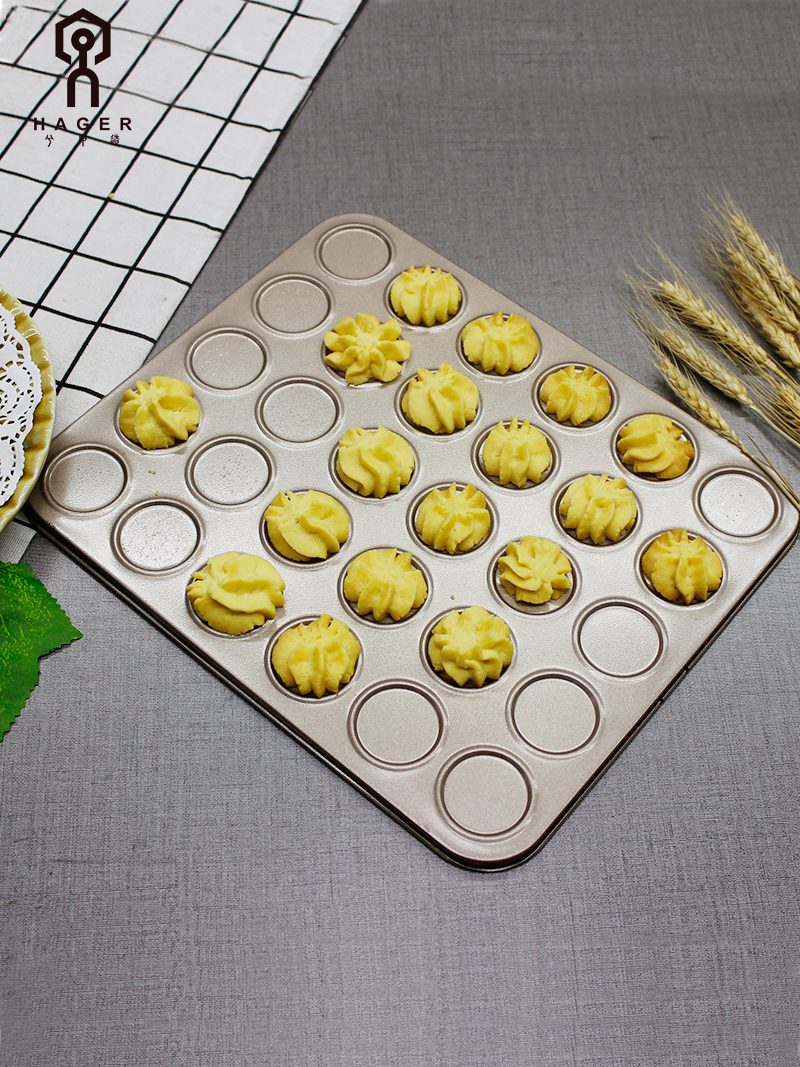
[0,562,82,739]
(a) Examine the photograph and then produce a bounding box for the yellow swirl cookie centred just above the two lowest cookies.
[343,548,428,622]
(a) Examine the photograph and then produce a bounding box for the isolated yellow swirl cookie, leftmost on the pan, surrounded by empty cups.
[119,375,201,448]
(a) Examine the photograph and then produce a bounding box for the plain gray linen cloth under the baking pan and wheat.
[0,0,800,1067]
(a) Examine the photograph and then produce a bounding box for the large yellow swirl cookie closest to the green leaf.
[187,552,286,634]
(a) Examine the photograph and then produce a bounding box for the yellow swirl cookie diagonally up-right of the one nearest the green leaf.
[263,489,350,563]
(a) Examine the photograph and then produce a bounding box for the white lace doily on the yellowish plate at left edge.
[0,304,42,504]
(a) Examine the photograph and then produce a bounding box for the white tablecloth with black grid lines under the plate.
[0,0,362,560]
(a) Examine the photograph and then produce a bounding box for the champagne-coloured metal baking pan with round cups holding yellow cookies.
[28,214,800,871]
